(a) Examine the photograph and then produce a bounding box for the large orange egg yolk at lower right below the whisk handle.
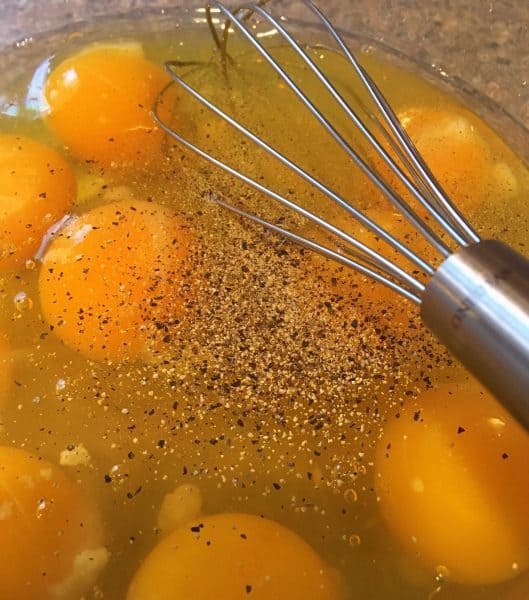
[376,384,529,585]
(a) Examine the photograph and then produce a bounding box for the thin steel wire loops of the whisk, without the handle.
[153,0,480,302]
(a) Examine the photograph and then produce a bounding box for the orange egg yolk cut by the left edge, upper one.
[0,134,76,271]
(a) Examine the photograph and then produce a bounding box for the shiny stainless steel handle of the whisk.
[421,240,529,430]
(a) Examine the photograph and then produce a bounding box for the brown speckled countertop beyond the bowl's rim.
[0,0,529,127]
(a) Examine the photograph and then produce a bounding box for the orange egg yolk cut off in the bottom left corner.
[0,446,107,600]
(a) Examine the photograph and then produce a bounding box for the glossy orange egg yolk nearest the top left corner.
[44,46,169,167]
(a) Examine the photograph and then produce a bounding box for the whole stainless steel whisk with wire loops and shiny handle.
[153,0,529,429]
